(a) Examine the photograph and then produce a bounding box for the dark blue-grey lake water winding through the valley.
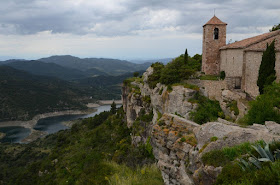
[0,105,121,143]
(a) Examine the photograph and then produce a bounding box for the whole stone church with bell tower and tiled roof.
[202,16,280,97]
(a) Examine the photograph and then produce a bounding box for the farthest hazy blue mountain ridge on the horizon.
[39,55,151,75]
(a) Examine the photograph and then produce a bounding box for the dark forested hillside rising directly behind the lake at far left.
[0,66,85,121]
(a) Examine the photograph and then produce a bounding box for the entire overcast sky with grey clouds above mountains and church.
[0,0,280,60]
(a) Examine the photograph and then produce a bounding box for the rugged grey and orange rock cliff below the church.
[122,67,280,185]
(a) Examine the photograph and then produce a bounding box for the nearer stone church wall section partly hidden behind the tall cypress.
[242,51,280,97]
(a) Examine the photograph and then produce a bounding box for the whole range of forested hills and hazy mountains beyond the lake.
[0,56,151,121]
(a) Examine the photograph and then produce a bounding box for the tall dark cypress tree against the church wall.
[257,40,276,94]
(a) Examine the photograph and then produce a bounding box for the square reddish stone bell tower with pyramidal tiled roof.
[201,15,227,75]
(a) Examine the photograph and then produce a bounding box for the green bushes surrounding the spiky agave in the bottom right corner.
[202,141,280,185]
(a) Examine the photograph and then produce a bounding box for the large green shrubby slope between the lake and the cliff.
[0,106,163,185]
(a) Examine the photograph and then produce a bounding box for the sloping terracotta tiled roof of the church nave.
[220,30,280,50]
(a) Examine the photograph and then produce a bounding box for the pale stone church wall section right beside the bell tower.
[220,49,243,77]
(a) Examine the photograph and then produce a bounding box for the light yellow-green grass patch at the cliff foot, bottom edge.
[105,161,164,185]
